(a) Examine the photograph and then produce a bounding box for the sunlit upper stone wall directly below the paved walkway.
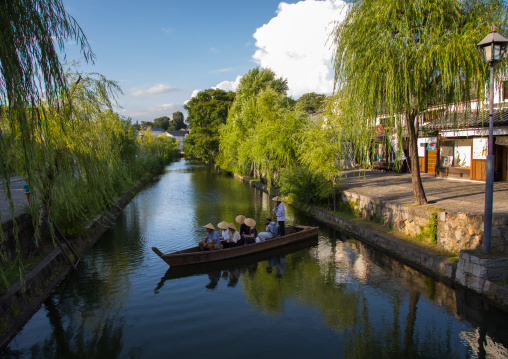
[341,191,508,253]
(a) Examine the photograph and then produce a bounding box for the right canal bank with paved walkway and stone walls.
[223,168,508,312]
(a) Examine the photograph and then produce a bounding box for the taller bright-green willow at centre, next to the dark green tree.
[220,67,298,180]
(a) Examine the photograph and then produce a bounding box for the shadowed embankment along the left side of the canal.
[0,175,153,350]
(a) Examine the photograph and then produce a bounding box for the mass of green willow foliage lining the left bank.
[0,68,178,285]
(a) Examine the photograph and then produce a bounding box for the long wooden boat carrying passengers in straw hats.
[152,225,319,267]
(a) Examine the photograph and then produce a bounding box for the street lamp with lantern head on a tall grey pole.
[476,25,508,253]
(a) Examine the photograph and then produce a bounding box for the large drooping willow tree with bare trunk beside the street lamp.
[333,0,506,204]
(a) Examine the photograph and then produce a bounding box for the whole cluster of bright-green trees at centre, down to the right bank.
[219,67,339,203]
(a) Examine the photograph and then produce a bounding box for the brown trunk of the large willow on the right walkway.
[406,110,427,205]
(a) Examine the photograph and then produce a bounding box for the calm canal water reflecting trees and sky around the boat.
[0,161,508,358]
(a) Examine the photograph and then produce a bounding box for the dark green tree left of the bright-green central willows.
[184,89,235,162]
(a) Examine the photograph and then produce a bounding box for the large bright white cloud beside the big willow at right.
[253,0,347,98]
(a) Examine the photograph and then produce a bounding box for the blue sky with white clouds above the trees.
[63,0,345,123]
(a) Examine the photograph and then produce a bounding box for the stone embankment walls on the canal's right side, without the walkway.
[219,169,508,311]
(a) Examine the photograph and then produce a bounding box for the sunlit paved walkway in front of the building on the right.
[340,170,508,215]
